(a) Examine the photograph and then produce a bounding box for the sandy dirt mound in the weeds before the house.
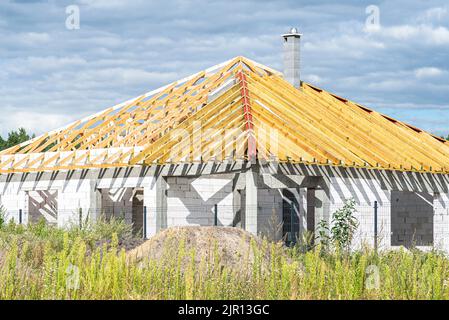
[127,226,285,271]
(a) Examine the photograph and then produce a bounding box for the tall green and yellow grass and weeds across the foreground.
[0,221,449,299]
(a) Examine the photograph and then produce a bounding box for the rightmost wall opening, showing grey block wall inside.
[391,191,434,248]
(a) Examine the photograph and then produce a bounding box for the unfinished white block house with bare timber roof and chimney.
[0,29,449,251]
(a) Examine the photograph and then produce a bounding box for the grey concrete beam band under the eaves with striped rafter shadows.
[0,161,449,193]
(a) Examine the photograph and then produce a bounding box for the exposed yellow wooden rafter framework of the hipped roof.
[0,57,449,173]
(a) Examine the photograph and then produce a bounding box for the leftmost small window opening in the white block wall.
[28,190,58,225]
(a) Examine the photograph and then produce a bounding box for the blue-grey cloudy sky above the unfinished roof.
[0,0,449,135]
